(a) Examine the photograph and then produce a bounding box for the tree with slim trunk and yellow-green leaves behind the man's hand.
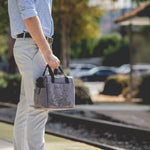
[53,0,102,68]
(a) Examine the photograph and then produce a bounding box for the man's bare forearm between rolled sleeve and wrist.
[24,16,52,55]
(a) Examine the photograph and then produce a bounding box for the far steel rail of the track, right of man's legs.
[50,112,150,136]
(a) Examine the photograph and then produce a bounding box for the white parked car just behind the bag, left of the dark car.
[70,64,96,77]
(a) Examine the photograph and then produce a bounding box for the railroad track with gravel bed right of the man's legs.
[47,111,150,150]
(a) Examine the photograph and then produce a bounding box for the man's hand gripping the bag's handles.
[44,51,60,72]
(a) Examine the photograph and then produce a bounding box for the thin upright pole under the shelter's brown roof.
[129,24,133,101]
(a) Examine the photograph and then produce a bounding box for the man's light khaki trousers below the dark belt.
[14,38,48,150]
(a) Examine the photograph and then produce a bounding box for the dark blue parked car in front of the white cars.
[77,67,117,81]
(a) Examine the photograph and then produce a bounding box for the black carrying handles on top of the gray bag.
[43,64,69,83]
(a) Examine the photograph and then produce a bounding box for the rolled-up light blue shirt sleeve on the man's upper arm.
[17,0,37,19]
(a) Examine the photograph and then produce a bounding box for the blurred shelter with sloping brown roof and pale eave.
[115,2,150,63]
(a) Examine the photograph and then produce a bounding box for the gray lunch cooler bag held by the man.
[34,65,75,110]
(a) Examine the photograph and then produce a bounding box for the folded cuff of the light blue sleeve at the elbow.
[20,9,37,19]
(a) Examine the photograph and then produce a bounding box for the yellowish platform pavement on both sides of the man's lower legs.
[0,122,102,150]
